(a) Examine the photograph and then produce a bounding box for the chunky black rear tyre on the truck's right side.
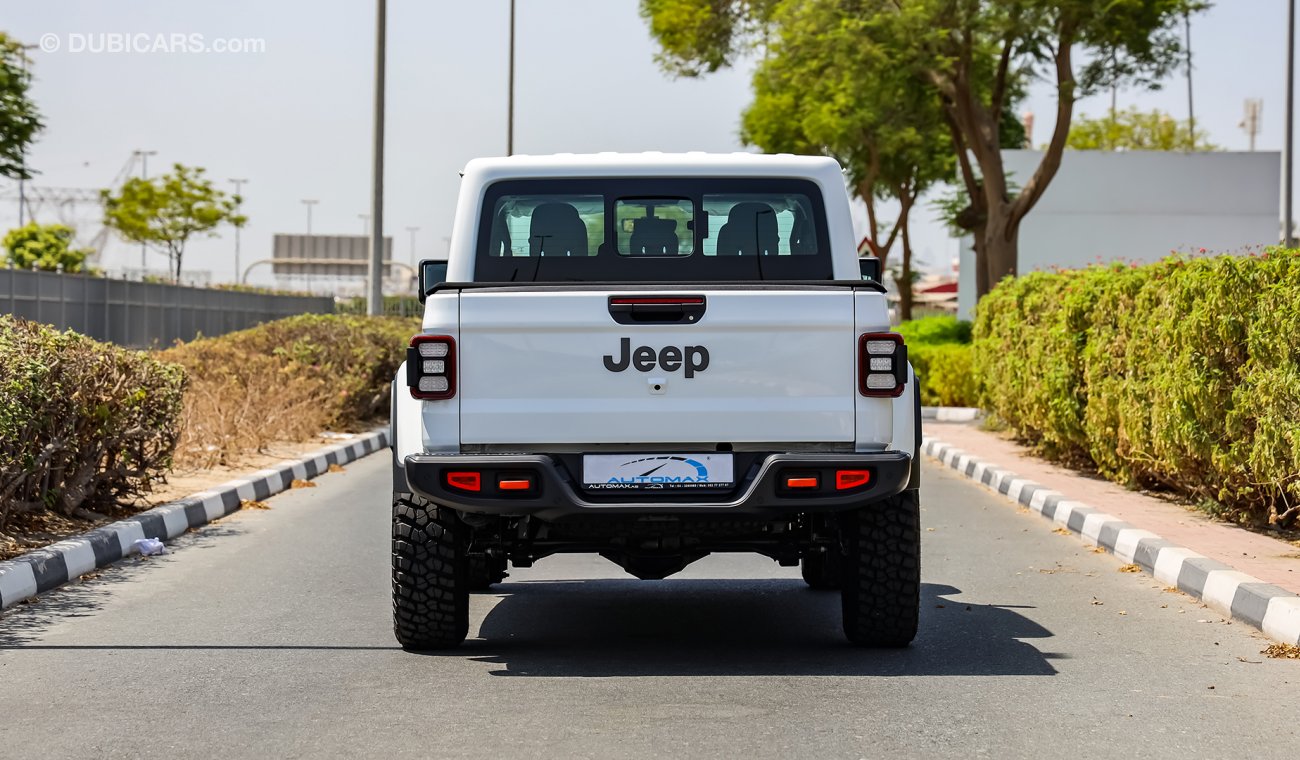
[840,490,920,647]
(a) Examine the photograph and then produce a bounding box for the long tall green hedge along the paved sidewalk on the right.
[975,249,1300,524]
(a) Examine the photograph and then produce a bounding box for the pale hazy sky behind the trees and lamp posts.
[0,0,1286,285]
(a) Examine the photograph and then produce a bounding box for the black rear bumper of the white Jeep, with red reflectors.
[403,451,911,520]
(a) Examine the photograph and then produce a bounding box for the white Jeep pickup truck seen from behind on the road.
[393,153,920,650]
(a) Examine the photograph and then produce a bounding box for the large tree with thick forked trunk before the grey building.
[641,0,1205,294]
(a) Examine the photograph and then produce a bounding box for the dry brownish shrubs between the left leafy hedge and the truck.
[161,314,419,468]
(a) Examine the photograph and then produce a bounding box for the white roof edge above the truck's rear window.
[464,152,841,181]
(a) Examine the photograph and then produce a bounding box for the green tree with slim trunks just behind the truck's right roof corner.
[741,0,954,320]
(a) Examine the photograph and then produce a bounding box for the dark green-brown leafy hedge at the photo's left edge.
[0,316,185,527]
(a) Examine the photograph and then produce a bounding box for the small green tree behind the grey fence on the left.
[100,164,247,282]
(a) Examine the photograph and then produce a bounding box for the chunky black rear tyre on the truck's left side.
[393,494,469,650]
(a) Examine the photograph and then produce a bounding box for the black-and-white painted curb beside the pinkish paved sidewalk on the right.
[922,438,1300,644]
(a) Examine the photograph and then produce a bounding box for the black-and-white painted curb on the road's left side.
[0,429,390,609]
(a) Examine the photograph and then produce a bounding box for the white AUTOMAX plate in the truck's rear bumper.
[582,453,736,491]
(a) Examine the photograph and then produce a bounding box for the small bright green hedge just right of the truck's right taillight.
[897,316,978,407]
